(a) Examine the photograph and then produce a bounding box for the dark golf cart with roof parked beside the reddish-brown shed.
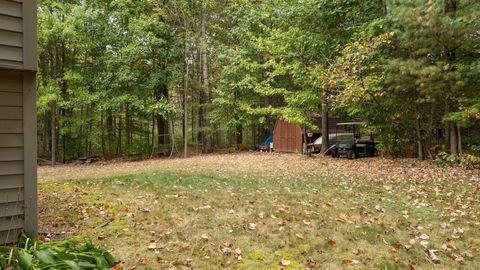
[332,122,377,159]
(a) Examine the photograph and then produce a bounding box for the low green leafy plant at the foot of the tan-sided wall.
[0,236,116,270]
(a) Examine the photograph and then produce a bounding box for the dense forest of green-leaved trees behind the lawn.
[37,0,480,162]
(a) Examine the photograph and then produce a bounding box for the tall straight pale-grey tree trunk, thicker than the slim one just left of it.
[200,10,213,153]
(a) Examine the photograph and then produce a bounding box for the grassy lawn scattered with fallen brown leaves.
[39,153,480,269]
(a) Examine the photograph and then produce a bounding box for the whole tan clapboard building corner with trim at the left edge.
[0,0,37,245]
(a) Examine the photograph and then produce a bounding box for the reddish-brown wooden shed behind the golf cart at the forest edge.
[273,116,341,153]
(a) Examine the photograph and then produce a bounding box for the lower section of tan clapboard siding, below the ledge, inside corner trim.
[0,70,24,245]
